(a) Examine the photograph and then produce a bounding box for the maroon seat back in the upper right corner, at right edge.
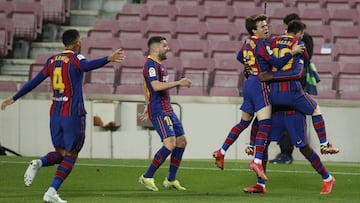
[329,9,359,26]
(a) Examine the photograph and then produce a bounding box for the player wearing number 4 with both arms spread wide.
[1,29,125,203]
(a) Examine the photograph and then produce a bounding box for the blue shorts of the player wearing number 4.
[50,115,86,152]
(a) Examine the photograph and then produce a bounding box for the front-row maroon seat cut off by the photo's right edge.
[339,62,360,99]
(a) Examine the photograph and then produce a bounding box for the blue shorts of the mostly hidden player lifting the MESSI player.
[268,111,309,148]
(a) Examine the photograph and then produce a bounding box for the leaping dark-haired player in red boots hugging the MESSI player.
[213,14,303,179]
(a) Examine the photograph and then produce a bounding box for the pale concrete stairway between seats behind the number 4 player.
[0,0,127,83]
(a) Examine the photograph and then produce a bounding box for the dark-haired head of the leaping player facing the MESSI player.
[245,14,269,38]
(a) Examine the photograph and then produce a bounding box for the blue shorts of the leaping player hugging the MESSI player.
[240,75,270,115]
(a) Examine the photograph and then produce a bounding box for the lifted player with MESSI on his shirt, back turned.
[259,20,339,157]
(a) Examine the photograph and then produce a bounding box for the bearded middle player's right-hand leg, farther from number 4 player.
[163,114,187,190]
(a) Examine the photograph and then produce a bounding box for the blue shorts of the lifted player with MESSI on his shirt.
[269,81,317,115]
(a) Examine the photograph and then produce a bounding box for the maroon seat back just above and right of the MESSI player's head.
[300,8,330,26]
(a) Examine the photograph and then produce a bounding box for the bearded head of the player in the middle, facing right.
[148,36,170,61]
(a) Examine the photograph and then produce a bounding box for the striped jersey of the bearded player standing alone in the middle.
[143,56,173,118]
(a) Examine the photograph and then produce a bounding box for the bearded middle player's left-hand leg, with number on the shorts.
[139,115,176,191]
